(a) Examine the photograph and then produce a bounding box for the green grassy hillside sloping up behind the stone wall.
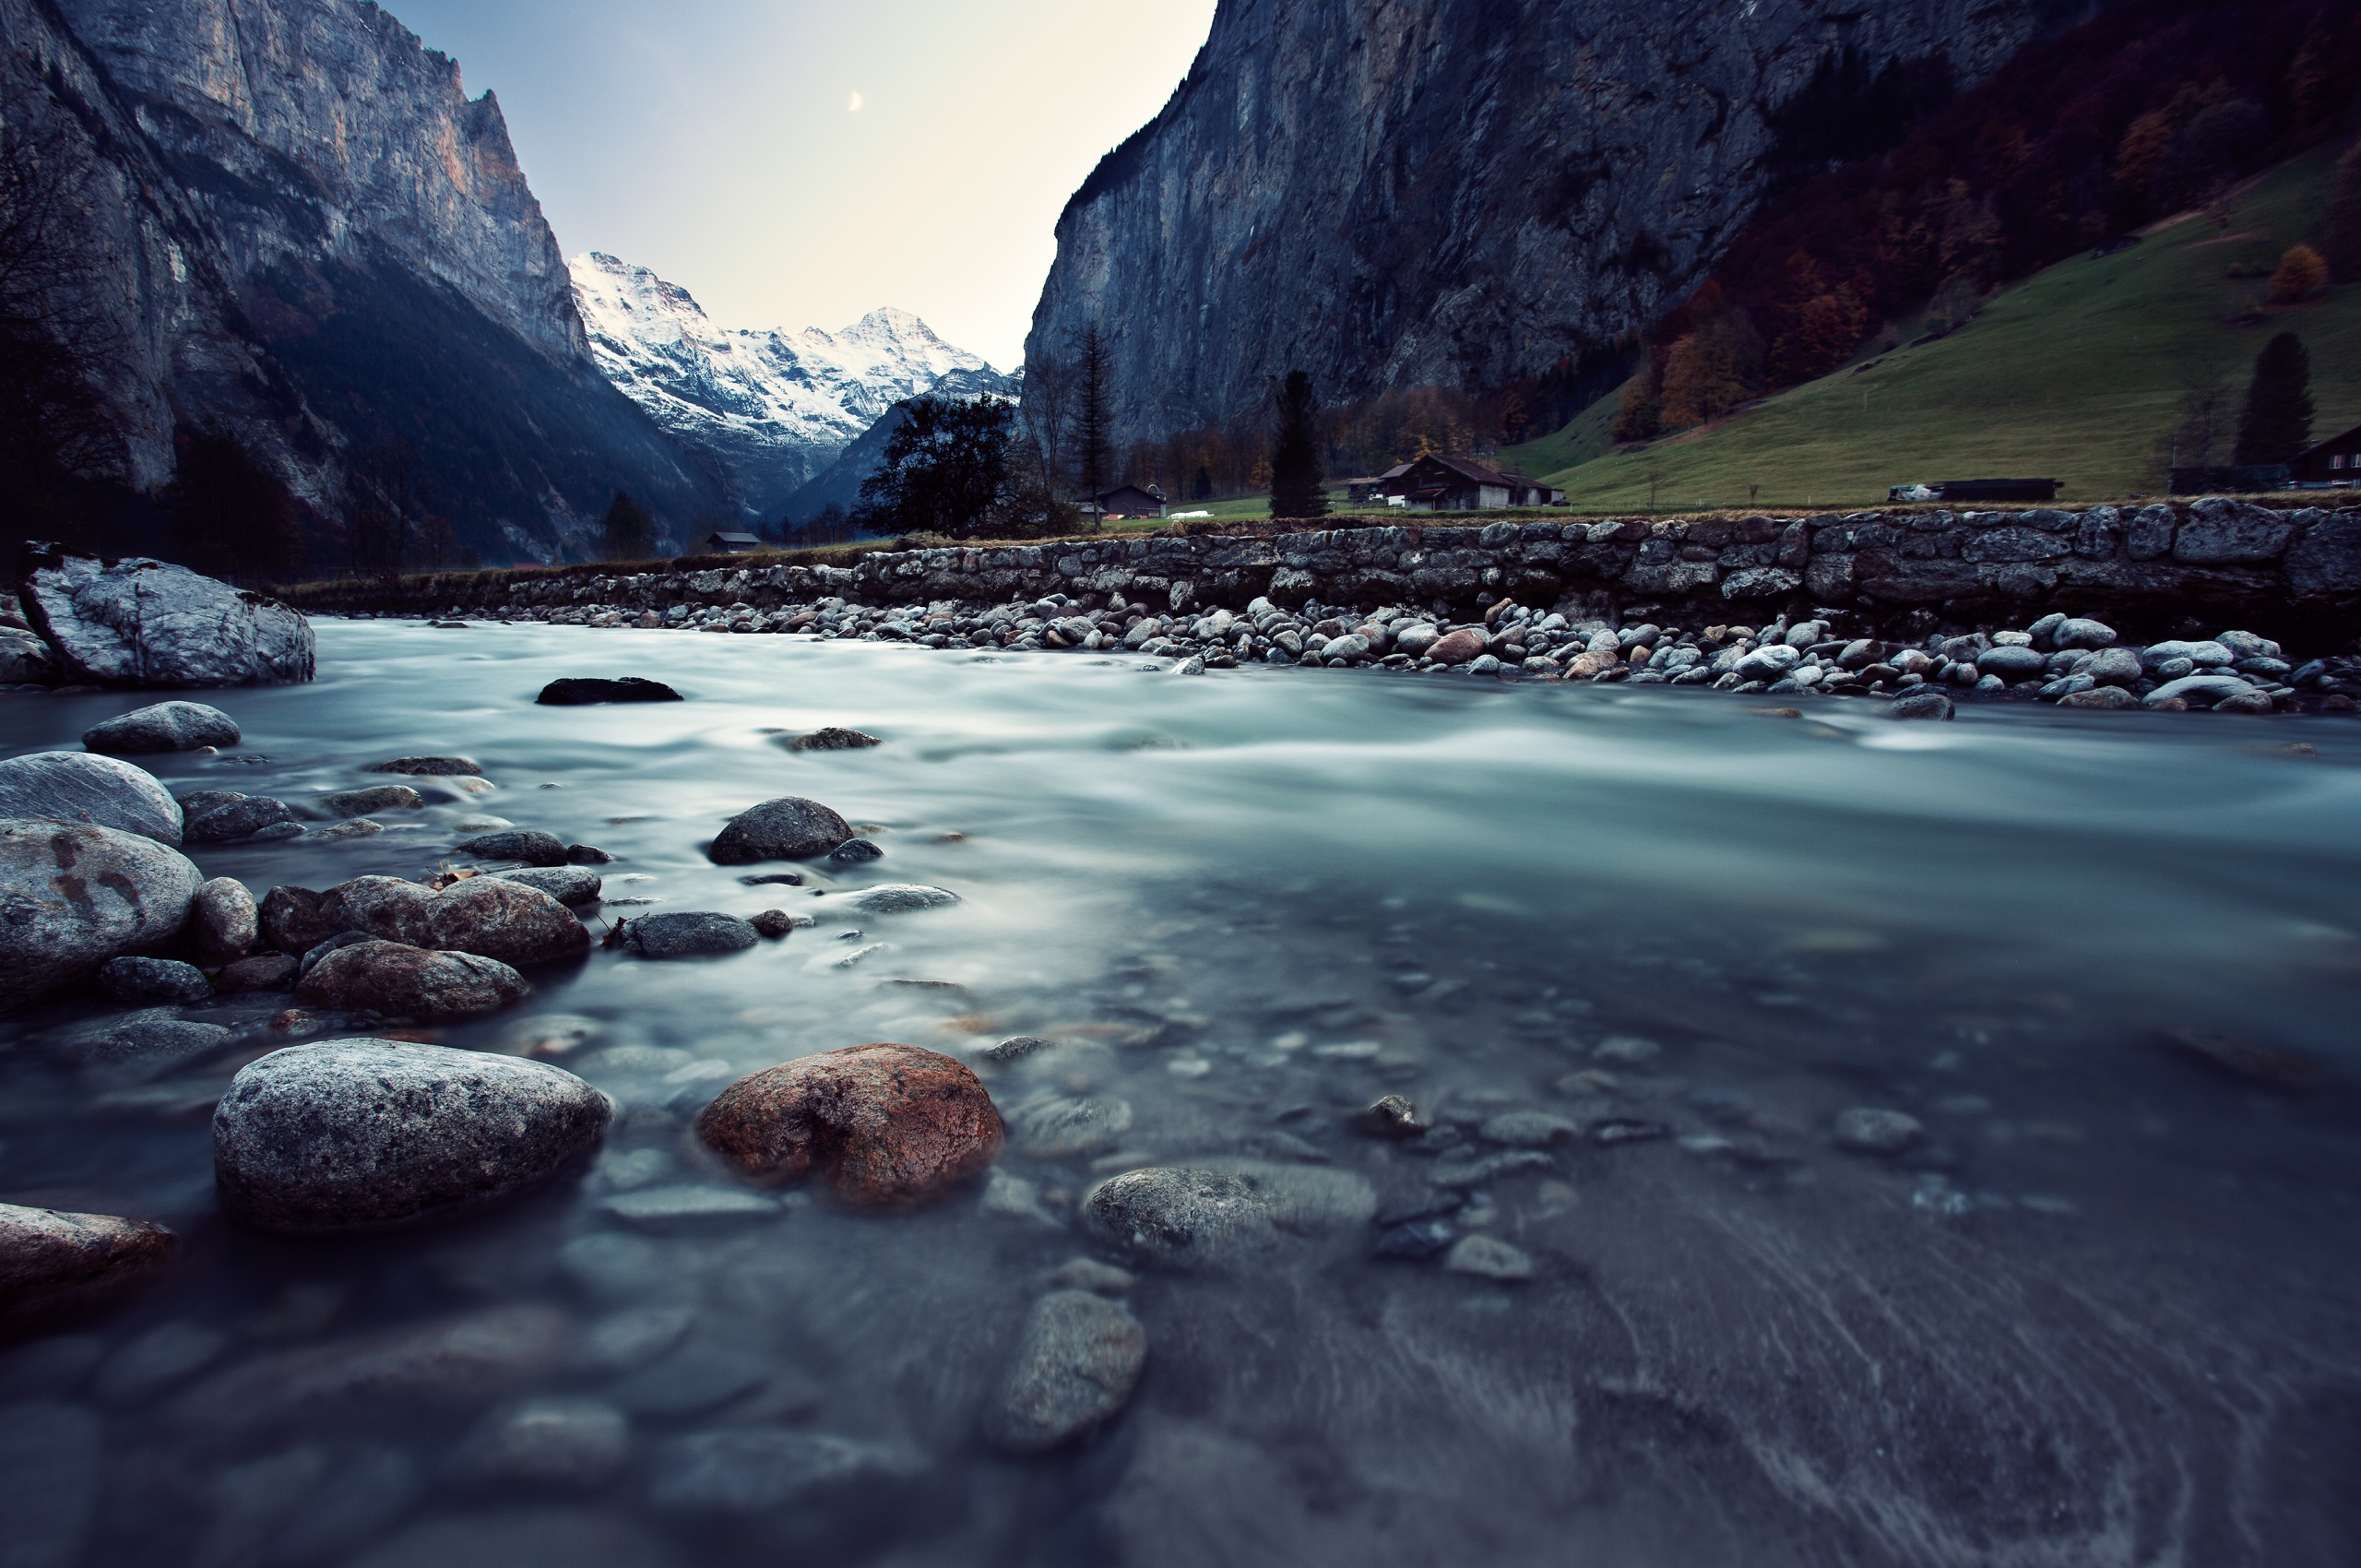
[1500,148,2361,510]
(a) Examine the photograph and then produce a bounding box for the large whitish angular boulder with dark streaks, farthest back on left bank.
[24,545,314,687]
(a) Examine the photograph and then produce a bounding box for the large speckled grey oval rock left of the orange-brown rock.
[212,1039,611,1232]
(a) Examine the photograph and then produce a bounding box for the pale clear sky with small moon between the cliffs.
[387,0,1214,371]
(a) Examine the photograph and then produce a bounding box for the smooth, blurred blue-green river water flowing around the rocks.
[0,624,2361,1568]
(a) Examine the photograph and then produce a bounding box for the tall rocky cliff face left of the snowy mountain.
[0,0,720,560]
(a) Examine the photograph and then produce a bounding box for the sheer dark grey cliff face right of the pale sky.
[1025,0,2082,442]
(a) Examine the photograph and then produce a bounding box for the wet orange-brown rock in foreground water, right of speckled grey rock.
[696,1044,1001,1209]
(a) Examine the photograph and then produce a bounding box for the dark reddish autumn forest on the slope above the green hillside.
[1612,0,2361,442]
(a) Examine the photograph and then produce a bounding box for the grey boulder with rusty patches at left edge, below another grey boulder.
[0,817,206,1013]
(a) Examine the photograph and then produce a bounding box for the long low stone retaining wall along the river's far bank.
[300,498,2361,647]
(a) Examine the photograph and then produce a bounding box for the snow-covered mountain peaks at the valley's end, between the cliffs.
[569,250,1013,519]
